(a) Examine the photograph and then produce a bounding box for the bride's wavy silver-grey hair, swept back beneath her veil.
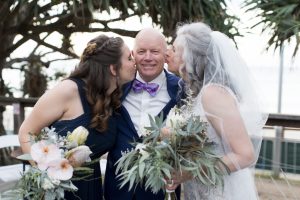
[176,23,212,95]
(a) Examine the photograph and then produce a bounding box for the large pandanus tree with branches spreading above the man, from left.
[0,0,239,138]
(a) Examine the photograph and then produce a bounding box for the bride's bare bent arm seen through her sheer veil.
[202,85,255,172]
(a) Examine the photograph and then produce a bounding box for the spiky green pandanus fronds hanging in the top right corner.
[246,0,300,56]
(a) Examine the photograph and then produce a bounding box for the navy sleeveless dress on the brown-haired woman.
[51,78,116,200]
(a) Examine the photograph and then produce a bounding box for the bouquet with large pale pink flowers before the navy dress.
[4,126,93,200]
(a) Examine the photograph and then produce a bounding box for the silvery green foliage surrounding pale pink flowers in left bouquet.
[1,128,92,200]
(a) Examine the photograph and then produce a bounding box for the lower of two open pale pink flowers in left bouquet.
[47,158,73,180]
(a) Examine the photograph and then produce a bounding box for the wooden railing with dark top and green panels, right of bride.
[257,114,300,177]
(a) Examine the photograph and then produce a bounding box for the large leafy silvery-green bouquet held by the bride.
[117,93,229,198]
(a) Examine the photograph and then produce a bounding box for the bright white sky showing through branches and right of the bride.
[3,0,300,115]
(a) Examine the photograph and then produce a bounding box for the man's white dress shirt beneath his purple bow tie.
[123,71,171,136]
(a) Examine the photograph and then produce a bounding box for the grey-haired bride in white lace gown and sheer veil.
[167,22,267,200]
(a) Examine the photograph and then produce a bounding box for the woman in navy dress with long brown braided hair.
[19,35,136,200]
